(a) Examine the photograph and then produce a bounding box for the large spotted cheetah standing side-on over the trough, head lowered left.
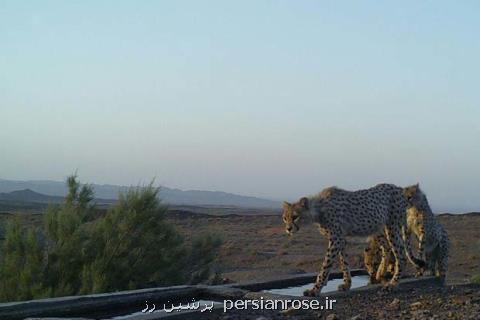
[282,184,424,296]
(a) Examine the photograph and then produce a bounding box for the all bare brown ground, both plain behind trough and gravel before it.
[169,209,480,320]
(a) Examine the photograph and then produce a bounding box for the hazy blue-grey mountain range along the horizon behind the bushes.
[0,179,280,208]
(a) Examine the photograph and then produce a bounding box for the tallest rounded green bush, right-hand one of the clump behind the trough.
[81,185,187,293]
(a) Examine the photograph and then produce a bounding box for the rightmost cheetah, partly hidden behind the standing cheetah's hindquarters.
[404,183,450,280]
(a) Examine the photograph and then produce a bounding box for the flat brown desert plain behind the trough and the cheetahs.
[168,212,480,284]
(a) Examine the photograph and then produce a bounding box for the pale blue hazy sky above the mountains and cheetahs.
[0,0,480,211]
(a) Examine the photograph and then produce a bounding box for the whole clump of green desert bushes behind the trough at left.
[0,176,221,301]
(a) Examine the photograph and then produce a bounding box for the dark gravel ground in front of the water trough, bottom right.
[202,285,480,320]
